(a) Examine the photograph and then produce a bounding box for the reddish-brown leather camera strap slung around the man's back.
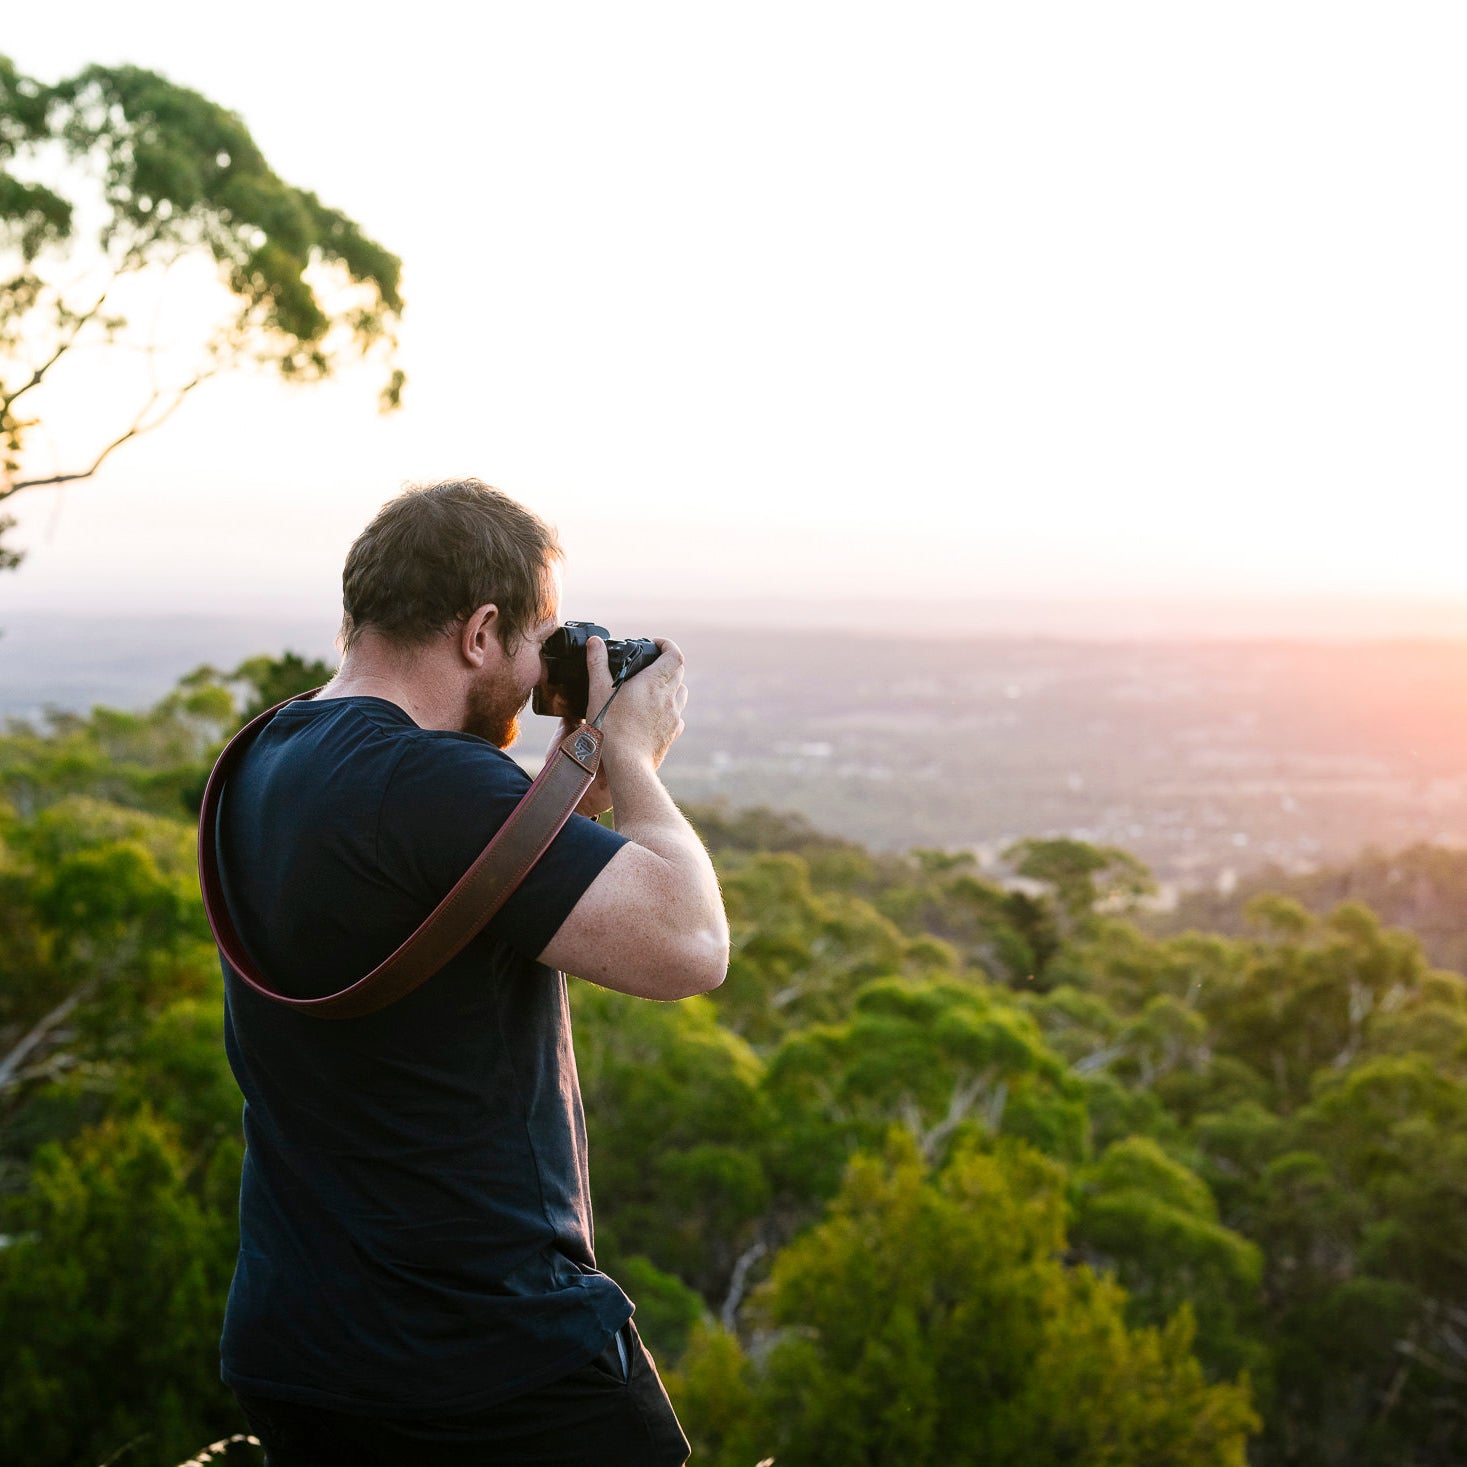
[198,688,604,1018]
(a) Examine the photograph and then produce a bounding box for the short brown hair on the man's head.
[342,478,565,650]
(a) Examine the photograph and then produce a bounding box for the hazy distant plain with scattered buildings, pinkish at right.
[0,615,1467,889]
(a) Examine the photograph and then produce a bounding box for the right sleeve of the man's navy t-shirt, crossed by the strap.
[377,734,626,958]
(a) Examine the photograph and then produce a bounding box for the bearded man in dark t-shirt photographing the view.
[217,480,728,1467]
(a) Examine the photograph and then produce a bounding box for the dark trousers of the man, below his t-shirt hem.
[236,1320,689,1467]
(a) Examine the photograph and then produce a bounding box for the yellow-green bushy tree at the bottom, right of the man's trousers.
[669,1133,1257,1467]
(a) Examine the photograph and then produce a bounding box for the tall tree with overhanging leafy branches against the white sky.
[0,57,403,566]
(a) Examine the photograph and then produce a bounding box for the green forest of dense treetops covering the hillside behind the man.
[0,654,1467,1467]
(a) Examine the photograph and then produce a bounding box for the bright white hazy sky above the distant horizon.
[0,0,1467,636]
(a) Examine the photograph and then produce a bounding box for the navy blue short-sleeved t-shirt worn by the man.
[219,698,632,1414]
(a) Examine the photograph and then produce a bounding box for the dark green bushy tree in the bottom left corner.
[0,1111,239,1467]
